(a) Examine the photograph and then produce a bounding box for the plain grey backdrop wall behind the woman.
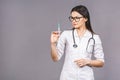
[0,0,120,80]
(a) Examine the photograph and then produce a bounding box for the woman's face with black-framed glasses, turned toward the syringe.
[69,11,87,29]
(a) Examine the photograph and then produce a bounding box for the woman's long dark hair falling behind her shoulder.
[71,5,94,33]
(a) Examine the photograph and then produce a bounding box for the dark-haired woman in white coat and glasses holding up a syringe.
[50,5,104,80]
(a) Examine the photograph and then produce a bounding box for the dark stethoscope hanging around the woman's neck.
[72,28,95,53]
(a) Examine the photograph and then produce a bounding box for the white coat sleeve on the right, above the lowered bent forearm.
[94,35,104,62]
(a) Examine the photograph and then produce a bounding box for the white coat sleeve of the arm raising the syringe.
[56,31,66,60]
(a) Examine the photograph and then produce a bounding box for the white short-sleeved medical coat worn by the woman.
[57,30,104,80]
